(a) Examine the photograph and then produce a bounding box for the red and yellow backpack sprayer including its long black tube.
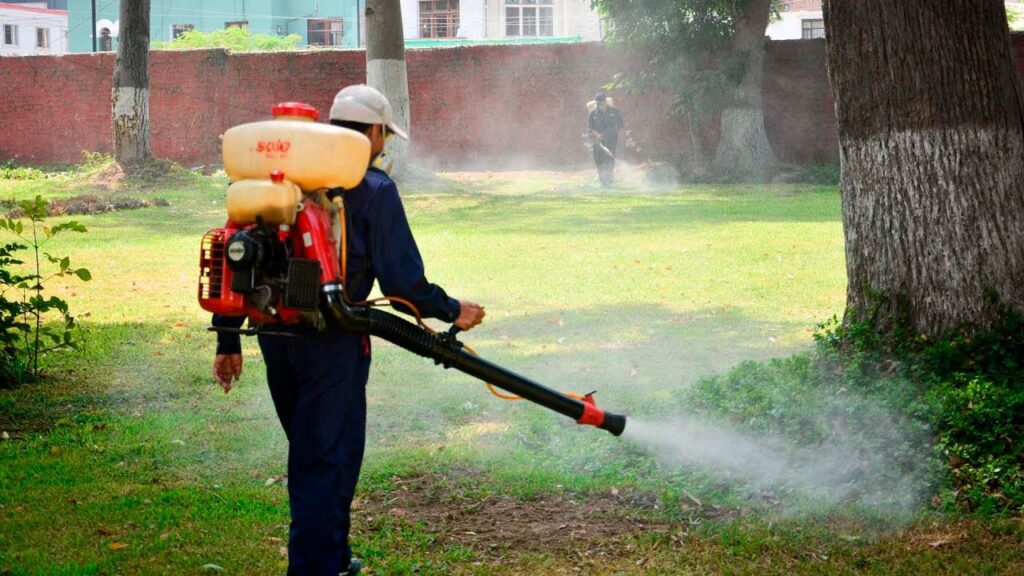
[193,102,626,436]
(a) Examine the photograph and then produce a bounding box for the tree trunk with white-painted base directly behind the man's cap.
[367,0,412,171]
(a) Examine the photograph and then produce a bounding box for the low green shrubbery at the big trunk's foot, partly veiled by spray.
[679,312,1024,512]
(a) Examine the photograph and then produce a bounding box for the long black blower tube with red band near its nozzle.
[321,284,626,436]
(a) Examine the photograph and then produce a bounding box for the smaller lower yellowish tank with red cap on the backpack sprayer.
[227,170,302,225]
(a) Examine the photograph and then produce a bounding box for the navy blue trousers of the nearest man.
[259,332,370,576]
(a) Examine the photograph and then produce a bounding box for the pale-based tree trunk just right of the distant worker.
[713,0,776,174]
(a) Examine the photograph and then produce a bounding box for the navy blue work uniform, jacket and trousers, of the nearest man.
[214,168,460,576]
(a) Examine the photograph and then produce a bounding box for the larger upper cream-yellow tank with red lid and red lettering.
[222,102,370,192]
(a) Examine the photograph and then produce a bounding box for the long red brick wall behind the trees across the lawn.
[0,39,847,169]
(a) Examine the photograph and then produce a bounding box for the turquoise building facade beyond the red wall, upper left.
[67,0,366,52]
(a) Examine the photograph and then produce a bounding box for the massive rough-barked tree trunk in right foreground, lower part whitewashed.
[824,0,1024,335]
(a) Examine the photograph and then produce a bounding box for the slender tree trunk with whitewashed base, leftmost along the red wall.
[112,0,150,171]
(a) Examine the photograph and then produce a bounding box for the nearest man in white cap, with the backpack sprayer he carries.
[199,85,626,576]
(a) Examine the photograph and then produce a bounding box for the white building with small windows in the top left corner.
[0,2,68,56]
